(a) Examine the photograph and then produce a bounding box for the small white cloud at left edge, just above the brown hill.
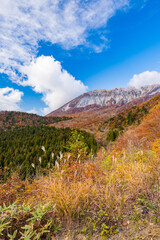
[0,87,23,111]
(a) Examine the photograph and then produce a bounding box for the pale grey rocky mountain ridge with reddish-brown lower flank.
[47,85,160,116]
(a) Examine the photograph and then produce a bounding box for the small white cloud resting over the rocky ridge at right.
[128,71,160,88]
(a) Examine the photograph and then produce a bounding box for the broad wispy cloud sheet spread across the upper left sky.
[0,0,130,82]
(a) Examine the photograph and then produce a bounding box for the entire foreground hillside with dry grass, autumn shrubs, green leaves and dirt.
[0,96,160,240]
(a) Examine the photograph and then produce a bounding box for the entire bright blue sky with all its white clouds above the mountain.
[0,0,160,115]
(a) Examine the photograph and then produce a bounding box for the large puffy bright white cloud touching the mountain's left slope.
[21,56,87,114]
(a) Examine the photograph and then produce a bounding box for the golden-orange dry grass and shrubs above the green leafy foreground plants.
[0,103,160,239]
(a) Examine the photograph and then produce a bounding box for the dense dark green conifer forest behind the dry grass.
[0,126,99,181]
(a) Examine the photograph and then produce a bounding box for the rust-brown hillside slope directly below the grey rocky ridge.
[51,94,160,145]
